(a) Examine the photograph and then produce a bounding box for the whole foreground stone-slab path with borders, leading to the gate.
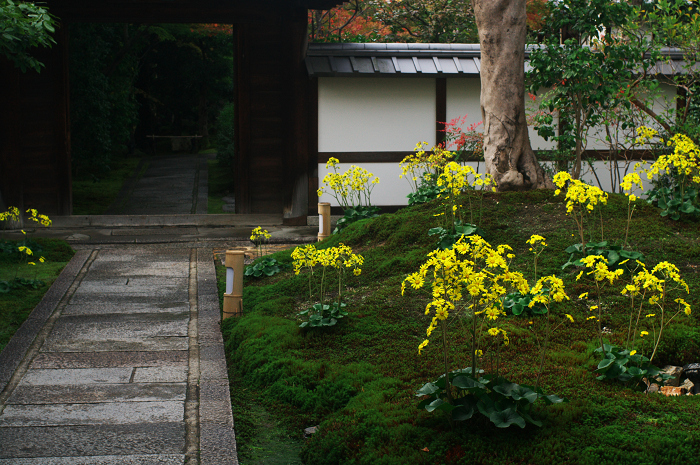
[0,244,237,465]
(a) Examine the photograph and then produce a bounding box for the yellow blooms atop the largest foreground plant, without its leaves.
[401,235,529,352]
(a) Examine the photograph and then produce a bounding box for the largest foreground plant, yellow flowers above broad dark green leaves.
[401,236,561,428]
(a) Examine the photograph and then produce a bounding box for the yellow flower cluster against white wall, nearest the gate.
[316,157,379,209]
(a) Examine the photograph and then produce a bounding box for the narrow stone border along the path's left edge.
[0,249,92,393]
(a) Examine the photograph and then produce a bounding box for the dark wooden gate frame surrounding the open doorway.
[0,0,341,224]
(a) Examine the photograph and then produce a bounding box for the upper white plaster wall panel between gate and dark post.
[318,77,435,151]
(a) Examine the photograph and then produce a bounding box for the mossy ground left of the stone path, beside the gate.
[0,239,75,351]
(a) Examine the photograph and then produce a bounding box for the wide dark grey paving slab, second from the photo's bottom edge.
[0,422,185,463]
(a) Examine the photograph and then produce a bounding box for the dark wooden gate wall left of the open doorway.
[0,25,71,215]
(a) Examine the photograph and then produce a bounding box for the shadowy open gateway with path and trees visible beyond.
[69,23,235,215]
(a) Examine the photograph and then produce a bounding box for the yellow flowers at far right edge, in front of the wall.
[637,126,700,184]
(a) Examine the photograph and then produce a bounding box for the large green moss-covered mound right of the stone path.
[218,191,700,465]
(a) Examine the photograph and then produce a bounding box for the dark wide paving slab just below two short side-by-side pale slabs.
[7,383,187,405]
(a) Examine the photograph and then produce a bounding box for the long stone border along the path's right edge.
[197,248,238,465]
